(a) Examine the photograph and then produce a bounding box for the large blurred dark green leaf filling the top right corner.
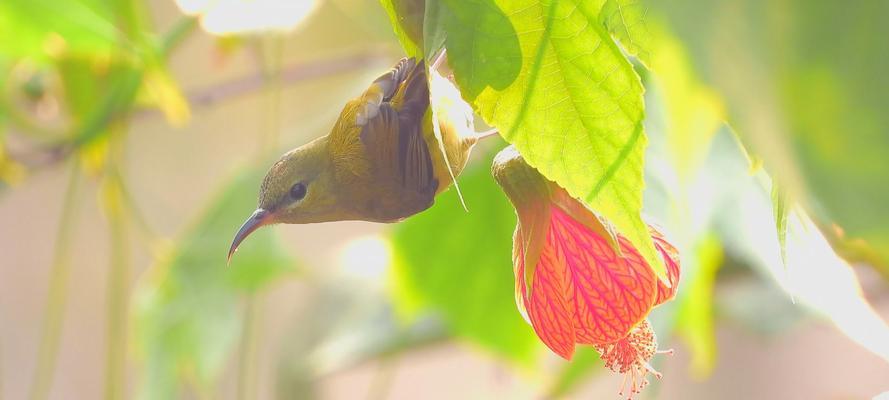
[649,0,889,272]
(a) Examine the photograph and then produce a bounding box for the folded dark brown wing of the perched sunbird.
[358,59,438,195]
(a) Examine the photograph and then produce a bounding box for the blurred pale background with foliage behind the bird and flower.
[0,0,889,399]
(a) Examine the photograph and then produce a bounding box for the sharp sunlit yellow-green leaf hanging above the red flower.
[445,0,664,276]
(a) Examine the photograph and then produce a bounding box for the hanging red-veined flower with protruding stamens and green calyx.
[492,146,679,392]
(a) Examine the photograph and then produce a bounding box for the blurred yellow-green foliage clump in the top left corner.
[0,0,192,155]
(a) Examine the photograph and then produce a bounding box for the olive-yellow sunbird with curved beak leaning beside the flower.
[228,58,480,259]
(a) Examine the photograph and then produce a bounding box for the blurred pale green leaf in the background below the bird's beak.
[134,170,293,399]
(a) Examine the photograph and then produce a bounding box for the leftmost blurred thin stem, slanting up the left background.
[30,160,80,400]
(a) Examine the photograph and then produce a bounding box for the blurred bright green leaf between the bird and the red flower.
[391,147,540,365]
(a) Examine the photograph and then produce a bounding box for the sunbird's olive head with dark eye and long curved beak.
[228,136,345,259]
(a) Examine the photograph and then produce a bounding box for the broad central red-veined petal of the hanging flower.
[548,207,657,344]
